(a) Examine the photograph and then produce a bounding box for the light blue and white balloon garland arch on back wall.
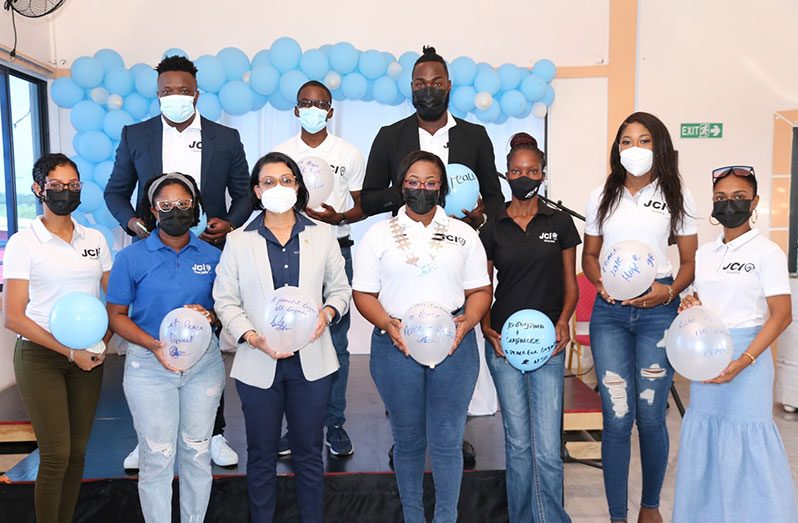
[50,37,556,256]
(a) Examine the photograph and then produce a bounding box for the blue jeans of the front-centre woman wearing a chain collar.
[371,329,479,523]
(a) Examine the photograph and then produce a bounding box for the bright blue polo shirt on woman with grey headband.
[108,230,221,339]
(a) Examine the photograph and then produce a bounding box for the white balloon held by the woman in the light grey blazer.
[263,286,319,353]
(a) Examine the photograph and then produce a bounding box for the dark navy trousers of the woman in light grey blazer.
[236,349,332,523]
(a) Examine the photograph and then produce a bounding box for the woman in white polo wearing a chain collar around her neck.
[352,151,491,523]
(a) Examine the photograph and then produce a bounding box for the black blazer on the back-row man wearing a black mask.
[360,113,504,216]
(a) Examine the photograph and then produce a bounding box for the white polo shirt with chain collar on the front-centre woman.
[352,206,490,318]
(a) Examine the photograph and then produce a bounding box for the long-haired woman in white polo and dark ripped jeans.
[582,112,697,523]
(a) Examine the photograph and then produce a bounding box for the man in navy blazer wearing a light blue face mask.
[105,56,252,247]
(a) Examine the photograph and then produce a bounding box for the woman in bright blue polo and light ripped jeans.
[108,173,224,521]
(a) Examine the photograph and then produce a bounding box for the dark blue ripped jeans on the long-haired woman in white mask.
[590,278,679,521]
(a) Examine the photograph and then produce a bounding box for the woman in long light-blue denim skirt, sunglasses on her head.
[673,165,798,523]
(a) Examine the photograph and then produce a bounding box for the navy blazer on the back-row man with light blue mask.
[105,115,252,235]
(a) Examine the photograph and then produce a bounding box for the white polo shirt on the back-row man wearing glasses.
[274,132,366,238]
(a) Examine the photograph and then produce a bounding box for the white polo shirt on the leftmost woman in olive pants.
[3,216,112,332]
